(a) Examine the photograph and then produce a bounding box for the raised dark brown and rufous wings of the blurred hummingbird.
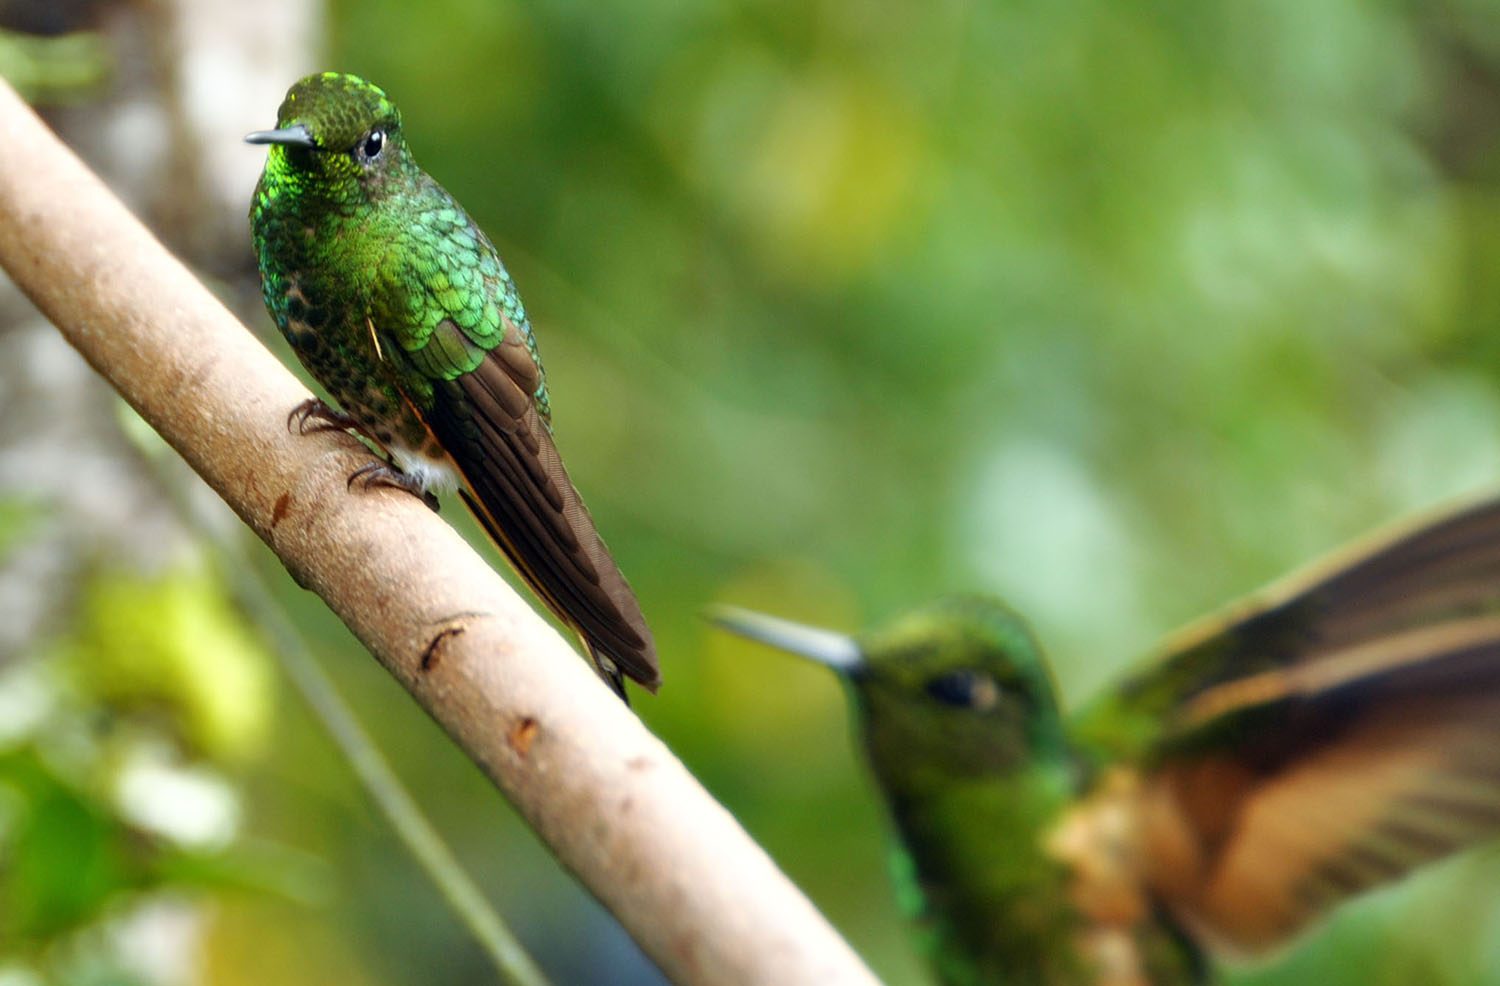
[1080,501,1500,951]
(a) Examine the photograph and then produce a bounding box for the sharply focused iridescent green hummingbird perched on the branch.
[245,72,662,698]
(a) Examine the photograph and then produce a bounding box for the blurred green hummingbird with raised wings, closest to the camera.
[714,500,1500,986]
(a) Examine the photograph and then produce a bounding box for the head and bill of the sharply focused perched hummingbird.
[245,72,411,203]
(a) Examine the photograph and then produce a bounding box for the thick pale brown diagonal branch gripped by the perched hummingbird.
[0,84,875,984]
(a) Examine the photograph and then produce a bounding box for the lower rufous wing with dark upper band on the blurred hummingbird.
[1139,606,1500,953]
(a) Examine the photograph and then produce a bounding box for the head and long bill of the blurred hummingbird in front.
[716,597,1064,786]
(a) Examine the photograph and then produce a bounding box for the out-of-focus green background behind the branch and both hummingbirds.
[0,0,1500,986]
